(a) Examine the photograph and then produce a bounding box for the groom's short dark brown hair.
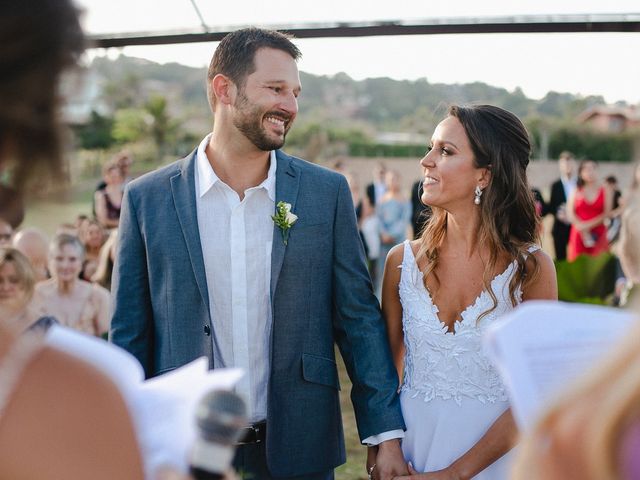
[207,27,302,110]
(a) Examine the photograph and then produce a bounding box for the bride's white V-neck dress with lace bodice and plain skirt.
[400,241,537,480]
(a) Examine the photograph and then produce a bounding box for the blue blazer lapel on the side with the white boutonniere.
[271,150,300,301]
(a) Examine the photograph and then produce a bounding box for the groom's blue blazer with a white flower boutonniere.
[111,151,404,476]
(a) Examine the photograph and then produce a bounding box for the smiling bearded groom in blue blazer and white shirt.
[111,28,406,480]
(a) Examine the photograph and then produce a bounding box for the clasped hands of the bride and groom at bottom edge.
[367,439,462,480]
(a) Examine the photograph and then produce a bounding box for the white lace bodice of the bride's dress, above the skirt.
[399,241,537,405]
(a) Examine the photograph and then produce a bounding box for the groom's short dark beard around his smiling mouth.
[233,92,292,152]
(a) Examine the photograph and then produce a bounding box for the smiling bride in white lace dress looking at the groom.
[382,105,557,480]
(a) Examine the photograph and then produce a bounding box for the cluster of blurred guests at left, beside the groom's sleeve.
[0,152,131,338]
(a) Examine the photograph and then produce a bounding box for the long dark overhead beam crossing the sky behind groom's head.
[89,13,640,48]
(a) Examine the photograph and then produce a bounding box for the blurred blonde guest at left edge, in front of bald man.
[0,247,55,332]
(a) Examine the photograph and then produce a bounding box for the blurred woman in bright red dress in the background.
[567,160,613,262]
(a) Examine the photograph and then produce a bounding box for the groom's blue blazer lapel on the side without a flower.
[171,151,211,314]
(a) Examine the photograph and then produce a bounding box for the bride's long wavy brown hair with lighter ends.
[416,105,539,320]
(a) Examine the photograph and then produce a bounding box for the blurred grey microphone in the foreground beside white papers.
[190,390,247,480]
